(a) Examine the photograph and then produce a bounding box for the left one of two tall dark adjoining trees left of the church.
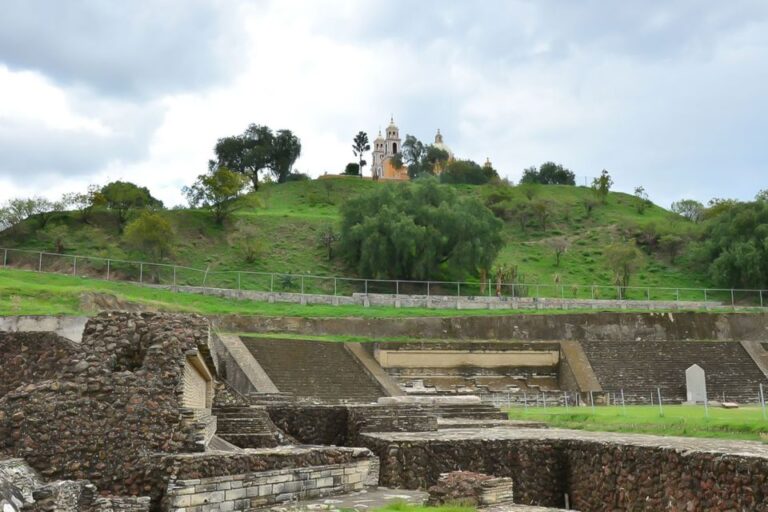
[214,124,275,190]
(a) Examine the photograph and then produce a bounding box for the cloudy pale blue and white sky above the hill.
[0,0,768,206]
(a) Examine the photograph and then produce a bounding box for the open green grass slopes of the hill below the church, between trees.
[0,178,708,294]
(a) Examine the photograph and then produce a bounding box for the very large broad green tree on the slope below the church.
[340,178,503,279]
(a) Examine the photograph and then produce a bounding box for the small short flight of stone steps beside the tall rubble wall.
[213,406,285,448]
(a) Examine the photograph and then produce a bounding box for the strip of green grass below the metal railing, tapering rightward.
[0,269,704,318]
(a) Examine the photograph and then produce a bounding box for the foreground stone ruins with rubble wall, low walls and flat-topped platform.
[0,312,768,512]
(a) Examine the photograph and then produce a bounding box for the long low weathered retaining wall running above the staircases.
[212,312,768,341]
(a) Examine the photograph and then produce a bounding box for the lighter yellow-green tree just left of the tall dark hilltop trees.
[182,162,247,224]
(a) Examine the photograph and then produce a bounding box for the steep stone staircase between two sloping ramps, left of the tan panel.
[243,338,387,403]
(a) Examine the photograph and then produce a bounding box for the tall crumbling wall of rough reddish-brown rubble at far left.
[0,313,209,495]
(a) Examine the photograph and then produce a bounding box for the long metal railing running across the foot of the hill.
[0,247,768,308]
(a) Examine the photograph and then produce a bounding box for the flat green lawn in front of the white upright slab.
[509,405,768,442]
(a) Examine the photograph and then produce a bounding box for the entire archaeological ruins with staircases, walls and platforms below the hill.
[0,311,768,512]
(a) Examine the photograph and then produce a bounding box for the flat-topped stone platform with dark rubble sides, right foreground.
[360,427,768,511]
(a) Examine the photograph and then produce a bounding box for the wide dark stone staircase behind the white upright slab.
[581,341,768,403]
